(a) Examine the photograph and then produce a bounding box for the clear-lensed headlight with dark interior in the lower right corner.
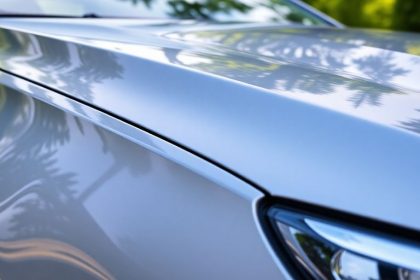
[267,207,420,280]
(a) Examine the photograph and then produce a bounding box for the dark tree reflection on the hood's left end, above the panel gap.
[0,30,123,117]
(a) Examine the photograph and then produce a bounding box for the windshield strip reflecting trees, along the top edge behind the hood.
[0,0,327,25]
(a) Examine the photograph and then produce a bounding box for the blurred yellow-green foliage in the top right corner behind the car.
[303,0,420,32]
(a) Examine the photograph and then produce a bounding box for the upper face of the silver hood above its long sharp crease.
[3,19,420,133]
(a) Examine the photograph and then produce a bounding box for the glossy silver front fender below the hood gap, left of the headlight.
[0,83,286,279]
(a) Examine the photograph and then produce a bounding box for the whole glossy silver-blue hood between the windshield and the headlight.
[0,20,420,232]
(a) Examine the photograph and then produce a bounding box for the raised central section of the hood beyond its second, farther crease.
[169,27,420,93]
